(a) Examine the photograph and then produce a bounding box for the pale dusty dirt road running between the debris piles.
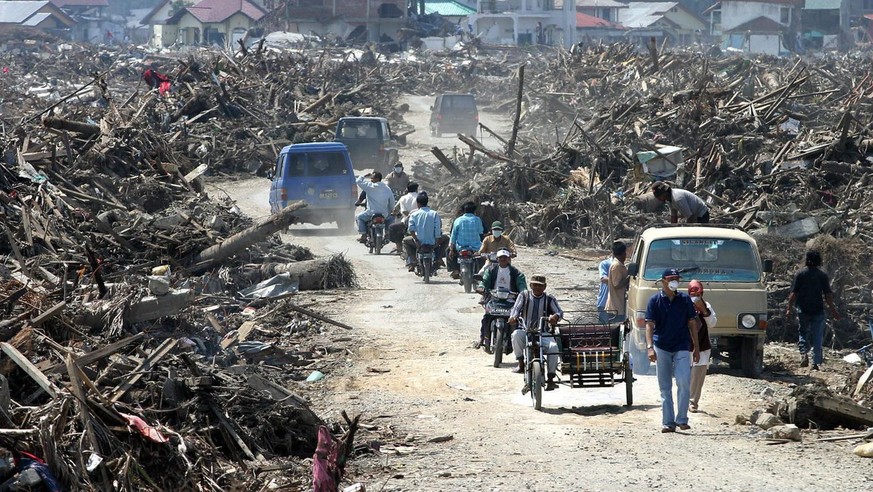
[213,98,873,491]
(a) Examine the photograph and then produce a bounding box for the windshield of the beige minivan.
[643,238,761,282]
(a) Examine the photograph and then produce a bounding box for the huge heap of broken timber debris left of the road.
[0,41,379,490]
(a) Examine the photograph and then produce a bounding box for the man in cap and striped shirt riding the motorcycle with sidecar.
[509,275,564,394]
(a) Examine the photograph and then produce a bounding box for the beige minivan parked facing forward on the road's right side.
[627,224,772,377]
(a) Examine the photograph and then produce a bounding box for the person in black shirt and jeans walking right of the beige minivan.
[785,250,840,371]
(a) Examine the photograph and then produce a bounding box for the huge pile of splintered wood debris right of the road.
[413,45,873,348]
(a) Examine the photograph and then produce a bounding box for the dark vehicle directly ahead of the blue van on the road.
[334,116,399,175]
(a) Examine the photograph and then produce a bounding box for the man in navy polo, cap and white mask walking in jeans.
[646,268,700,432]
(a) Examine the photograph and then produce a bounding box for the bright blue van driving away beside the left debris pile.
[270,142,358,231]
